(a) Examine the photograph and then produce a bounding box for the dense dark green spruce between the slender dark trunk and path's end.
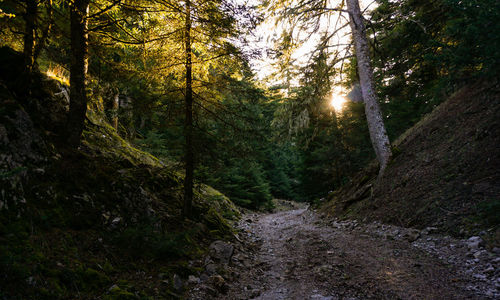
[193,74,294,208]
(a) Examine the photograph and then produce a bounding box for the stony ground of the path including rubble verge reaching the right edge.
[191,204,499,300]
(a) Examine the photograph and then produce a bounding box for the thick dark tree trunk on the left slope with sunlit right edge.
[66,0,89,148]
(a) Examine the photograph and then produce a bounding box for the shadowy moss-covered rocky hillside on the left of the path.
[0,48,239,299]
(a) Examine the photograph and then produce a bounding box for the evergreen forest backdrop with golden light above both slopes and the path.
[0,0,500,210]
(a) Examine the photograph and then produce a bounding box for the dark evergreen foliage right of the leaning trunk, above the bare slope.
[371,0,500,139]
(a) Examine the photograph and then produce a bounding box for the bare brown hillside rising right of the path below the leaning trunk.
[323,82,500,247]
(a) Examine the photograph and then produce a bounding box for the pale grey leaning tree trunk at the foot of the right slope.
[346,0,392,177]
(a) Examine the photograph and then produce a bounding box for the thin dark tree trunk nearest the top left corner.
[23,0,38,74]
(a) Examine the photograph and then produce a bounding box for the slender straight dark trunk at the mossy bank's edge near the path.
[183,0,194,218]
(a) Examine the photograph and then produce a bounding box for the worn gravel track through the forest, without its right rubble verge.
[194,208,488,300]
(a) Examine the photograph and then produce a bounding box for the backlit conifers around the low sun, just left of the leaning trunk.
[274,52,373,201]
